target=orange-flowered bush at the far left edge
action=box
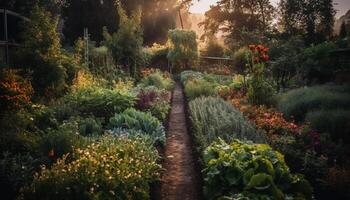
[0,68,33,111]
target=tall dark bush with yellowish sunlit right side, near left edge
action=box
[20,6,67,97]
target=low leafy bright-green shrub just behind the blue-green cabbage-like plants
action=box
[65,88,136,119]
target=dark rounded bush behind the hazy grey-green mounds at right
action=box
[300,42,336,83]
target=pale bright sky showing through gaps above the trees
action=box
[190,0,350,18]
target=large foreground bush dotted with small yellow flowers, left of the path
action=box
[22,136,161,200]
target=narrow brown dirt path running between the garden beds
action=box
[161,83,200,200]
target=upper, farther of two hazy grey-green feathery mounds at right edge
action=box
[278,86,350,122]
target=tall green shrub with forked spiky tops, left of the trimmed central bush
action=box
[103,4,144,76]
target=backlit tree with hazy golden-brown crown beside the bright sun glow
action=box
[202,0,274,44]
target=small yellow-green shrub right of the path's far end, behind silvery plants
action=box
[185,79,216,100]
